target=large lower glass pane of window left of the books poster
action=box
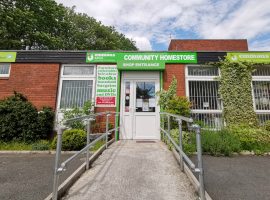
[60,80,93,108]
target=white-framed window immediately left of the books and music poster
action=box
[58,65,95,109]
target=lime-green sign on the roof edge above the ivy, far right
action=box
[227,52,270,63]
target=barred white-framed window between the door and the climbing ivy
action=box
[186,65,223,129]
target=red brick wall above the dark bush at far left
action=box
[0,63,60,109]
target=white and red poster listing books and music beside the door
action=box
[95,65,118,107]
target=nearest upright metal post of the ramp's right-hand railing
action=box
[193,125,205,200]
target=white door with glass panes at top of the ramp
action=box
[120,72,160,140]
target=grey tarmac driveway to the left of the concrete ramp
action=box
[0,154,85,200]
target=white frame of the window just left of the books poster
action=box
[57,64,97,112]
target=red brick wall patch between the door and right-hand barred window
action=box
[163,64,186,96]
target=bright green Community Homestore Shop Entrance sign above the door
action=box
[86,52,197,70]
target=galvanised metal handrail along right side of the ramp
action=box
[160,112,205,200]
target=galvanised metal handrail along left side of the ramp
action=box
[52,112,120,200]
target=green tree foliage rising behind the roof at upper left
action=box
[0,0,137,50]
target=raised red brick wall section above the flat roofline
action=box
[169,39,248,51]
